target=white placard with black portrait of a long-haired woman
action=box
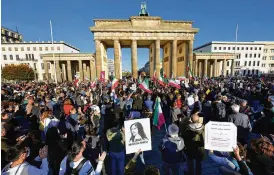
[125,118,151,154]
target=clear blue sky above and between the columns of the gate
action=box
[1,0,274,70]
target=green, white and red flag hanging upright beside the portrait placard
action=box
[153,97,165,130]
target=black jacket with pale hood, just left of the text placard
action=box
[183,123,206,160]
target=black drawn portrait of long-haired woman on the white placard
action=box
[129,122,148,143]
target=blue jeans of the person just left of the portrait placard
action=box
[109,151,125,175]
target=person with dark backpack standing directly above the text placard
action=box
[210,95,227,122]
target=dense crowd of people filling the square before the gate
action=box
[1,77,274,175]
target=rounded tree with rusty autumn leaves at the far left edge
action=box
[2,64,34,81]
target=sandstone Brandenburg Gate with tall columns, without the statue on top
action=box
[90,16,198,78]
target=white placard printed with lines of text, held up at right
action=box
[205,121,237,152]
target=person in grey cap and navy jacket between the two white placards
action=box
[159,124,185,175]
